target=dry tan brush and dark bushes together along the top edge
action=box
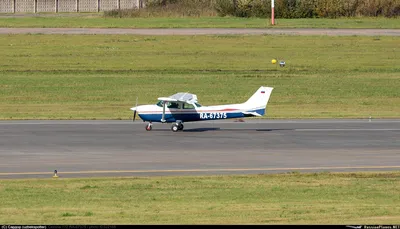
[105,0,400,18]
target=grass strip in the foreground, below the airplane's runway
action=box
[0,172,400,225]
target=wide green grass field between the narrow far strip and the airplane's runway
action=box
[0,35,400,119]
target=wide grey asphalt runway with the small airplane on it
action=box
[0,119,400,179]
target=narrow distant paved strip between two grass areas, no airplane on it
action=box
[0,28,400,36]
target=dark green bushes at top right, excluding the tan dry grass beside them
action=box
[147,0,400,18]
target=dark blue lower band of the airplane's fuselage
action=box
[138,108,265,122]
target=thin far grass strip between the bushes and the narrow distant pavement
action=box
[0,13,400,29]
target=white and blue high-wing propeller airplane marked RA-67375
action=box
[131,86,273,132]
